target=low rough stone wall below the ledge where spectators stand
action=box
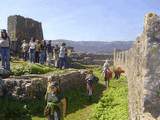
[0,71,85,99]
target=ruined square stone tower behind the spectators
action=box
[8,15,43,55]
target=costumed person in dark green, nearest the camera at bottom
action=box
[44,81,67,120]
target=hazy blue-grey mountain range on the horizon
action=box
[52,39,133,54]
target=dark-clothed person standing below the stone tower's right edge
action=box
[39,40,46,64]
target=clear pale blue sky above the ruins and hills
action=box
[0,0,160,41]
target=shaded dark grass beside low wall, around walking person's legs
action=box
[64,84,105,114]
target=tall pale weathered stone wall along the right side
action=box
[114,13,160,120]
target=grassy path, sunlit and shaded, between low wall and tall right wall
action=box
[33,69,128,120]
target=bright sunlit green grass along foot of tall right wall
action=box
[88,70,128,120]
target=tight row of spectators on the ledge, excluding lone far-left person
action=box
[21,38,67,68]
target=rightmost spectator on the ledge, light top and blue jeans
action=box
[59,43,66,69]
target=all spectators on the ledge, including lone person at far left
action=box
[0,29,68,71]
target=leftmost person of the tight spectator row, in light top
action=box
[21,40,29,61]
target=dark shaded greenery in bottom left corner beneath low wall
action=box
[0,98,45,120]
